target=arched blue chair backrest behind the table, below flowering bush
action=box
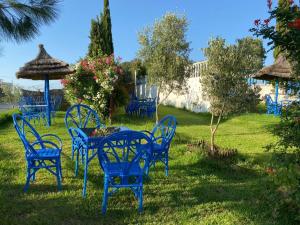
[65,104,104,136]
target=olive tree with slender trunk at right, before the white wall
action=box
[200,38,265,154]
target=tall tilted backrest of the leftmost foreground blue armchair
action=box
[12,114,45,157]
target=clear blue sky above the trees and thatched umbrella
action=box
[0,0,273,89]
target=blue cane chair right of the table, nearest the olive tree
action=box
[144,115,177,176]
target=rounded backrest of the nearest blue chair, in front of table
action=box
[98,131,152,175]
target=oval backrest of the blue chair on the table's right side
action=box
[151,115,177,146]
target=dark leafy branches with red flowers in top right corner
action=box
[250,0,300,77]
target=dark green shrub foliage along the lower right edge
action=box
[267,102,300,222]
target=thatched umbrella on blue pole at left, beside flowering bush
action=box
[16,45,75,126]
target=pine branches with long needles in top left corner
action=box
[0,0,59,41]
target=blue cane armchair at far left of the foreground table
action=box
[13,114,62,192]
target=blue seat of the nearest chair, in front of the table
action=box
[105,162,143,176]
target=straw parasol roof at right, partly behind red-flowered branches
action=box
[252,55,293,80]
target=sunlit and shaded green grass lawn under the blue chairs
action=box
[0,107,288,225]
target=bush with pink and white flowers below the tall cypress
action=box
[61,55,123,117]
